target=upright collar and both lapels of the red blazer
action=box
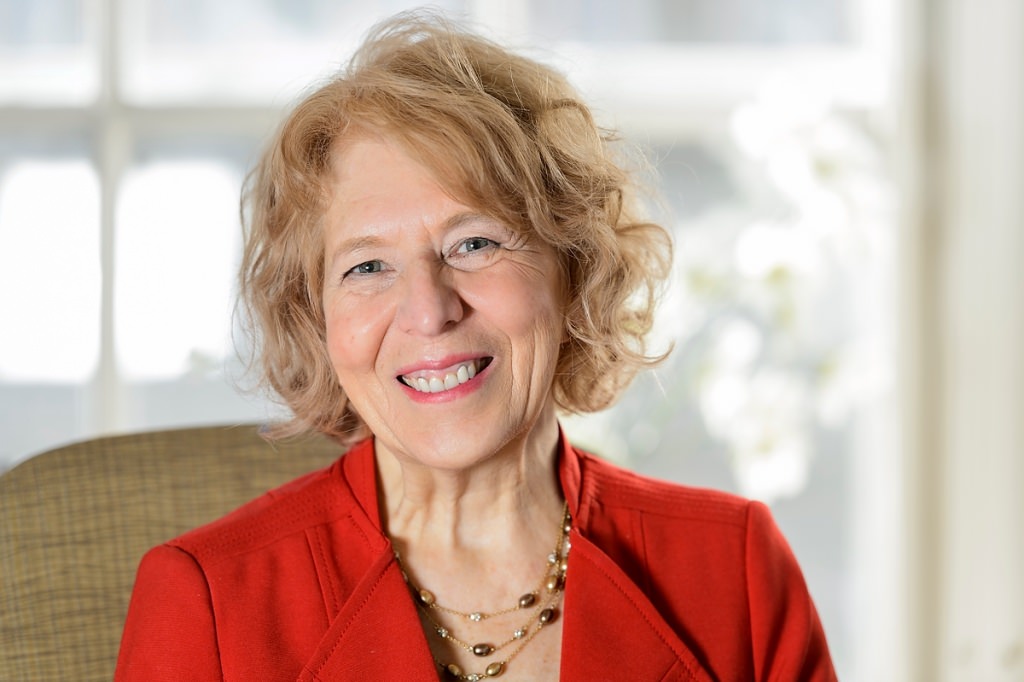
[299,433,713,682]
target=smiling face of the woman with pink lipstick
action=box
[324,136,564,469]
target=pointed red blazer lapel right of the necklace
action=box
[560,530,713,682]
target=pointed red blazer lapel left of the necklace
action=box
[299,550,437,682]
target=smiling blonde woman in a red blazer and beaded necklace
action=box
[118,11,835,680]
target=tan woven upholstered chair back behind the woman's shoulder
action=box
[0,425,340,682]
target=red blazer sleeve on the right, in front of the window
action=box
[745,502,837,682]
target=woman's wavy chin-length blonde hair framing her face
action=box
[240,13,672,444]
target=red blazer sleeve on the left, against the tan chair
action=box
[114,545,223,682]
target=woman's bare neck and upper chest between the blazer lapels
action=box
[375,406,565,679]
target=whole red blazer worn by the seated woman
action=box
[116,430,836,682]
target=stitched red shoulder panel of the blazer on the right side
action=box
[577,449,755,527]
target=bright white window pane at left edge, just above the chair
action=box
[0,152,100,382]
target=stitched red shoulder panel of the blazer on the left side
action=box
[168,458,355,563]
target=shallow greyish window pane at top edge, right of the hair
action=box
[529,0,852,44]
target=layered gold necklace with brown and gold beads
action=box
[395,505,572,682]
